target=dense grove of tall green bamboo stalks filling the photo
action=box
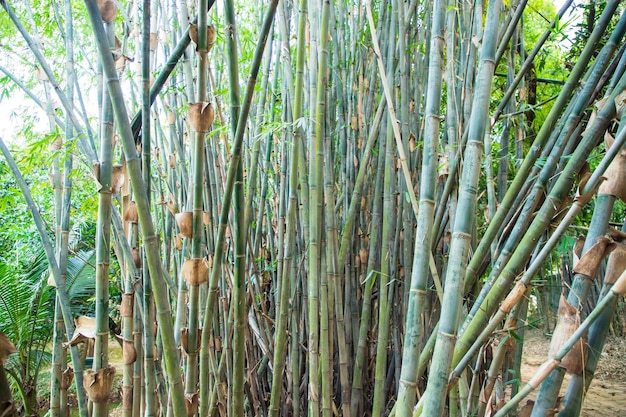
[0,0,626,417]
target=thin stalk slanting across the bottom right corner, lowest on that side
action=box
[494,271,626,417]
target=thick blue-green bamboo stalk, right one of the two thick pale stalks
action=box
[416,1,502,416]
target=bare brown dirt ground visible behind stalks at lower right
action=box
[522,330,626,417]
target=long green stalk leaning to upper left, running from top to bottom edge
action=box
[80,0,186,417]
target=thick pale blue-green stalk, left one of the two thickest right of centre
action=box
[396,0,444,417]
